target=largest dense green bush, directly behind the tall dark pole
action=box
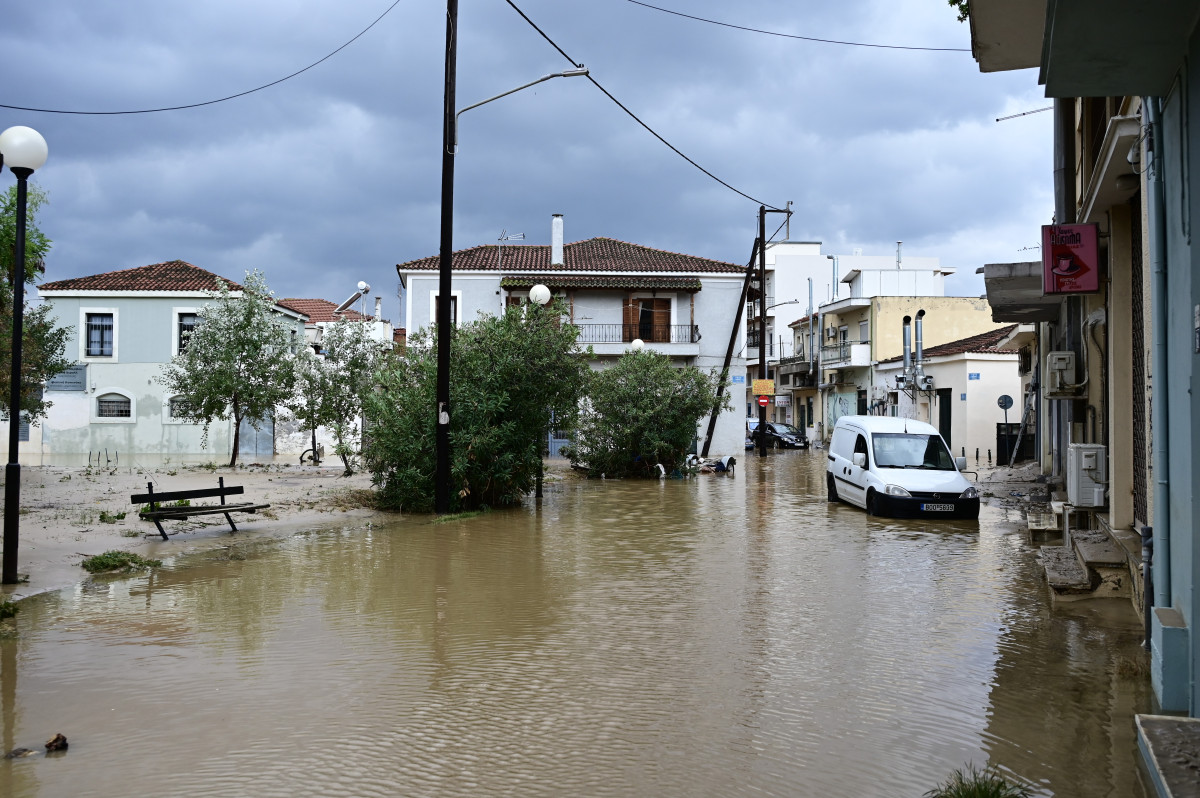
[365,302,590,512]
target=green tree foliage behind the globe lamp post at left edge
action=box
[0,184,73,421]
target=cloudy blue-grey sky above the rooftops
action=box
[0,0,1052,320]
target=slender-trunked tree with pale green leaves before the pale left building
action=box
[158,271,295,467]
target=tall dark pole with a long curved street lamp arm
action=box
[433,0,588,515]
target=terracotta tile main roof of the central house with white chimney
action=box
[396,236,745,275]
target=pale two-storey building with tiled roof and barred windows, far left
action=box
[26,260,306,462]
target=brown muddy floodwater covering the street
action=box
[0,451,1150,798]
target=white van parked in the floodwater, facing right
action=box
[826,415,979,518]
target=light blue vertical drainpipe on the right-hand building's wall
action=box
[1141,97,1174,607]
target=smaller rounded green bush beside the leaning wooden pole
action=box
[563,349,730,478]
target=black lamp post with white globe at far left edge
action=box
[0,125,49,584]
